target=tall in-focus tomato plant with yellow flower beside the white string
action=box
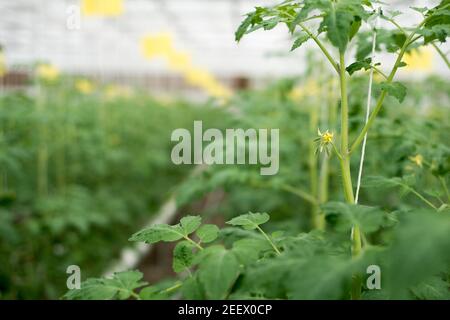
[232,0,450,299]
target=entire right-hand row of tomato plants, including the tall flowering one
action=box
[64,0,450,299]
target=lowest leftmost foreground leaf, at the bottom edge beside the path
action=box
[64,271,147,300]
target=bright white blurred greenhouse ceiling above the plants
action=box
[0,0,448,77]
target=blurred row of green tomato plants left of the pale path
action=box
[0,72,224,299]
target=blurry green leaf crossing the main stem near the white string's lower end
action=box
[322,202,386,233]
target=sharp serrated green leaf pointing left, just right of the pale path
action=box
[129,224,184,243]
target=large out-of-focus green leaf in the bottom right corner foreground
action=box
[382,209,450,299]
